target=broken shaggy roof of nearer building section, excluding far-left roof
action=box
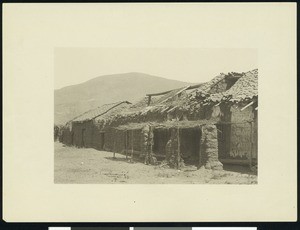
[97,70,257,126]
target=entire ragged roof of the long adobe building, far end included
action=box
[65,69,258,127]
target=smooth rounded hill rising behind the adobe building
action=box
[54,72,190,124]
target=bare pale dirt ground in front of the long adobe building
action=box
[54,142,257,184]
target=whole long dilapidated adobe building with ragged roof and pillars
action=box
[59,69,258,169]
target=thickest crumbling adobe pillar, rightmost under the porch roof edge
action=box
[199,125,223,170]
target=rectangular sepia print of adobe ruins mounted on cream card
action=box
[54,48,259,184]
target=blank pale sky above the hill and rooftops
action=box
[54,48,258,89]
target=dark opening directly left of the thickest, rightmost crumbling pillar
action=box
[180,128,201,166]
